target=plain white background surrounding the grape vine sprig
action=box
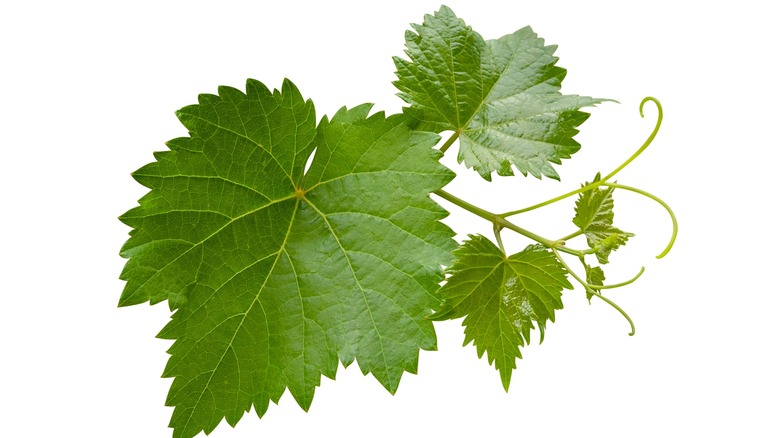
[0,0,780,438]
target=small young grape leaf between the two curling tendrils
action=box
[572,173,634,264]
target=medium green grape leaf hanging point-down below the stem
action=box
[431,235,572,391]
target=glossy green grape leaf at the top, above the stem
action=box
[394,6,605,181]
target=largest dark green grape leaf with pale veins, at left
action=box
[120,80,456,437]
